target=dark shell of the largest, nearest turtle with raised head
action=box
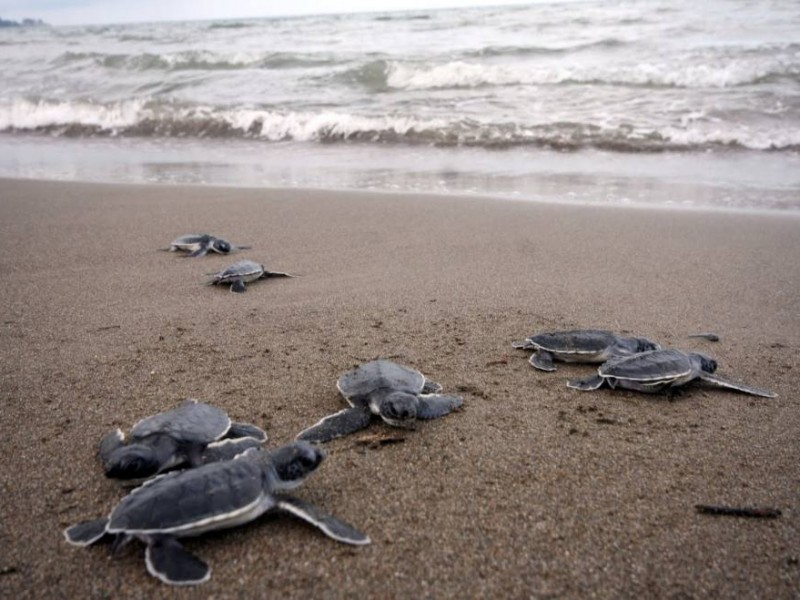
[108,459,268,536]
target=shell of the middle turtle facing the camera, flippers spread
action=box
[336,360,425,404]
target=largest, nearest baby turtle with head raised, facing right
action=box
[64,442,370,585]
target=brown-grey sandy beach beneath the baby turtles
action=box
[0,180,800,598]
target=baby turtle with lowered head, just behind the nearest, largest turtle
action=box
[100,399,267,481]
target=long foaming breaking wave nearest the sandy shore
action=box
[0,100,800,152]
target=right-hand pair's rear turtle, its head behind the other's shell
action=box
[512,329,661,371]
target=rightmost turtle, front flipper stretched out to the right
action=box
[567,350,775,398]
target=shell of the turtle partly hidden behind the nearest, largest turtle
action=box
[131,400,231,444]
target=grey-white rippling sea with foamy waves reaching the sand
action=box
[0,0,800,211]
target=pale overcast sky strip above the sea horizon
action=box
[0,0,558,25]
